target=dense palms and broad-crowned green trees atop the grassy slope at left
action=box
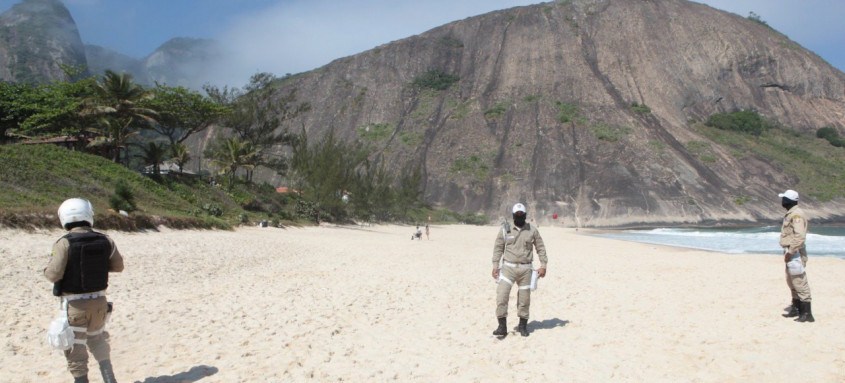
[0,69,229,166]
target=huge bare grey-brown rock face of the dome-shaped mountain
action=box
[247,0,845,226]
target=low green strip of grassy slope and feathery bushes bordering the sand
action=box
[0,142,442,230]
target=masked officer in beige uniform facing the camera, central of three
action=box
[493,203,548,336]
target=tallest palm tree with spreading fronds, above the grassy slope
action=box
[82,70,157,162]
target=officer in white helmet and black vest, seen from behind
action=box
[44,198,123,383]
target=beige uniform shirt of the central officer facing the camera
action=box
[493,222,548,269]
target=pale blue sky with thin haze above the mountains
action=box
[0,0,845,86]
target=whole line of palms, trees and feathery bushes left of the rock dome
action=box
[0,69,424,222]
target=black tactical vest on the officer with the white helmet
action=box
[60,232,112,294]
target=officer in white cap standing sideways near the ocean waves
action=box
[778,190,816,322]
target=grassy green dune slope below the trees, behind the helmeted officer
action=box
[0,145,285,229]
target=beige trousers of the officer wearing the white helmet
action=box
[65,297,111,377]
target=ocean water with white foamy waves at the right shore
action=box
[596,226,845,259]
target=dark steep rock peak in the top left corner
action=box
[0,0,86,83]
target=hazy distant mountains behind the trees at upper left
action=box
[0,0,222,89]
